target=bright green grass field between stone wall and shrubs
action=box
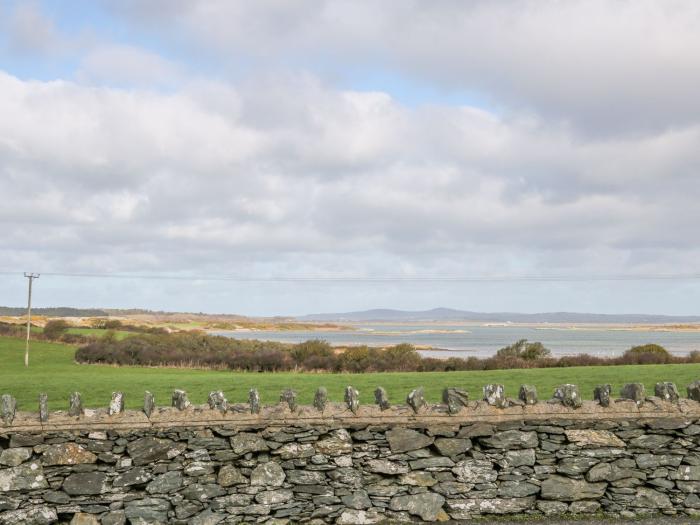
[0,337,700,410]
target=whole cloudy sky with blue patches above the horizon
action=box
[0,0,700,315]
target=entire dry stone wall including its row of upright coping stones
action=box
[0,384,700,525]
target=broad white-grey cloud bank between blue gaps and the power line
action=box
[0,68,700,286]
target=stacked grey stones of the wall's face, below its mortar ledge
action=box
[0,418,700,524]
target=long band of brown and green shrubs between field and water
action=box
[75,332,700,373]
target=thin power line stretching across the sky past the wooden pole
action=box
[0,271,700,283]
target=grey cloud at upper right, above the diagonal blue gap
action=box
[104,0,700,136]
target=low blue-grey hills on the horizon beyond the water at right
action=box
[296,308,700,324]
